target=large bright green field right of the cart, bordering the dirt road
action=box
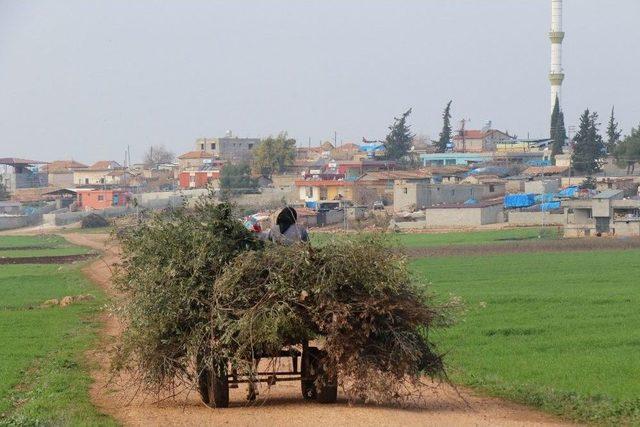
[412,250,640,424]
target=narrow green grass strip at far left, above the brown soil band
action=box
[0,236,90,258]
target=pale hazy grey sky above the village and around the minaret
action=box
[0,0,640,162]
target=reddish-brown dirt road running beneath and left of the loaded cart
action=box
[65,234,567,426]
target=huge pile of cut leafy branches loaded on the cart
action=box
[113,197,456,401]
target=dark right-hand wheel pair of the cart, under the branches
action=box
[302,347,338,403]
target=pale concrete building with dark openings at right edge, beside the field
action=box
[561,190,640,237]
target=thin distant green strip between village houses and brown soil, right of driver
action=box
[311,227,561,248]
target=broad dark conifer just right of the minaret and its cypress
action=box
[571,109,605,175]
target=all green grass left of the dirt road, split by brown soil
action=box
[0,236,111,425]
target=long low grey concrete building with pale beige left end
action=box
[393,180,506,212]
